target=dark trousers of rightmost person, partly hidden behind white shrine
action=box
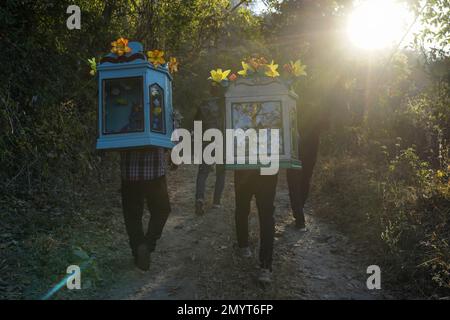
[286,129,319,223]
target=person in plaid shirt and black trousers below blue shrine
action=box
[120,147,170,271]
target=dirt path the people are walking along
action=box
[99,166,386,299]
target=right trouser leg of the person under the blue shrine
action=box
[145,176,170,252]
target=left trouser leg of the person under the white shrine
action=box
[234,170,253,248]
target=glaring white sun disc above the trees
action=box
[347,0,413,49]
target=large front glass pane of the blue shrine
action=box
[103,77,144,134]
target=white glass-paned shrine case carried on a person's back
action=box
[225,77,302,170]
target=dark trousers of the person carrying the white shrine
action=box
[234,170,278,269]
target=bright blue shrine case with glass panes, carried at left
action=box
[97,42,174,149]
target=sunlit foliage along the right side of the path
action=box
[267,1,450,296]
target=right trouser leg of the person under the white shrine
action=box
[256,175,278,271]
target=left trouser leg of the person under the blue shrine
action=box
[121,181,144,257]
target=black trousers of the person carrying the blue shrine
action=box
[122,176,170,256]
